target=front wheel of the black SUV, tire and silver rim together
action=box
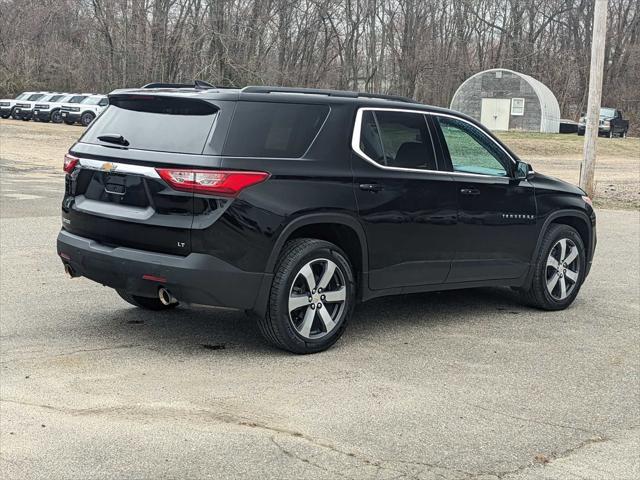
[523,224,587,310]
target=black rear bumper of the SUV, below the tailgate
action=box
[57,230,271,310]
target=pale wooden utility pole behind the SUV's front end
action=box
[580,0,609,198]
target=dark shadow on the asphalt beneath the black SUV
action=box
[100,288,528,356]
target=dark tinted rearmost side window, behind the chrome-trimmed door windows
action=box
[223,102,329,158]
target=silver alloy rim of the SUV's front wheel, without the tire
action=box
[546,238,580,301]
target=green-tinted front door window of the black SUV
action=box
[437,117,507,177]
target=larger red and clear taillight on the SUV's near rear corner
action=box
[156,168,269,197]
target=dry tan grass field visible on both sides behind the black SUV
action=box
[0,120,640,209]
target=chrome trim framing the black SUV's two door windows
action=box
[351,107,517,179]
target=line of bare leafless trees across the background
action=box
[0,0,640,125]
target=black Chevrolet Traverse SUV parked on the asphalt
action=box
[57,85,596,353]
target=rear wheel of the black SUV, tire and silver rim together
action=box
[258,238,355,353]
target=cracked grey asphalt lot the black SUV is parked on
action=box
[0,138,640,480]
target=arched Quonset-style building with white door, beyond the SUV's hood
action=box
[451,68,560,133]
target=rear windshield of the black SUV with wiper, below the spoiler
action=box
[82,96,217,154]
